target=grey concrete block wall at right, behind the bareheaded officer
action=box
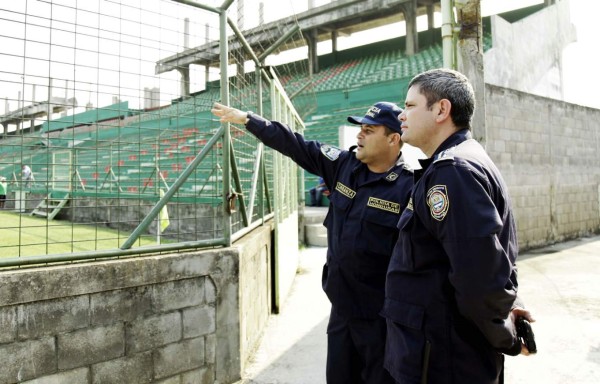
[486,84,600,250]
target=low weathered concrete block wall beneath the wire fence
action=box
[0,226,272,384]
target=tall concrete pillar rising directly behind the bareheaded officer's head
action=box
[457,0,487,147]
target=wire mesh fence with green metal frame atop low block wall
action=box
[0,0,315,266]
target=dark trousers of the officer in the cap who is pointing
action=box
[326,309,395,384]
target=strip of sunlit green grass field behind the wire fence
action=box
[0,211,156,258]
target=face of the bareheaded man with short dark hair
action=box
[398,86,439,153]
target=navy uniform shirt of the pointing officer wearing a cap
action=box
[246,114,413,318]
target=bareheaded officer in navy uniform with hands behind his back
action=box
[382,69,533,384]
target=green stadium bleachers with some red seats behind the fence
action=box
[0,31,491,206]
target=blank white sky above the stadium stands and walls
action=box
[0,0,600,121]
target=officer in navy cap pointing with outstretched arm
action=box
[212,102,412,384]
